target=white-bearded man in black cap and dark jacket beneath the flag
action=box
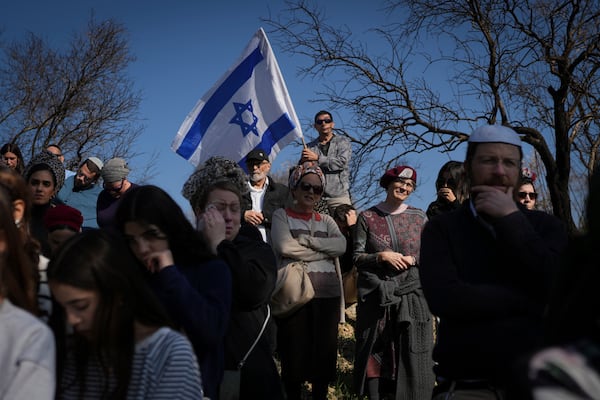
[242,149,289,243]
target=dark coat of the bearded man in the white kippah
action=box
[420,201,567,386]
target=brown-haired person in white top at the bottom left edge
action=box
[0,187,55,400]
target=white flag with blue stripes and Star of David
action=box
[171,28,302,169]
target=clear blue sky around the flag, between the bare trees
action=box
[0,0,464,213]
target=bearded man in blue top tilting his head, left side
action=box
[58,157,104,228]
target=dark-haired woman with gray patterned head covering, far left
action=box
[23,150,65,257]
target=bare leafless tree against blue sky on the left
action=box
[0,17,142,169]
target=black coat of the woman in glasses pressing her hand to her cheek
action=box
[217,224,283,400]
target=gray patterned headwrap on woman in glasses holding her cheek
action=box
[183,156,249,207]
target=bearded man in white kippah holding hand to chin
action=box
[420,125,567,400]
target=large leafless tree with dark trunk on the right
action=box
[265,0,600,234]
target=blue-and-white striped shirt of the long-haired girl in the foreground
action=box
[57,327,203,400]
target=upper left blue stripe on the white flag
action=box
[176,47,264,160]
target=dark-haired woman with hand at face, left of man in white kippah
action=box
[427,161,466,219]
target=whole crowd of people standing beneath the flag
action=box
[0,111,600,400]
